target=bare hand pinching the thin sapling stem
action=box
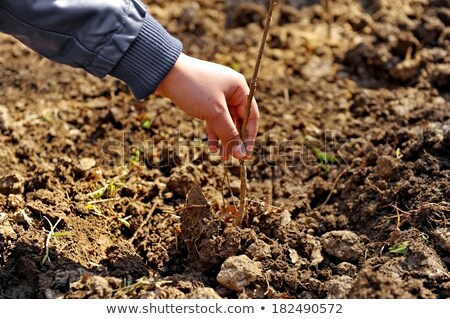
[156,54,259,160]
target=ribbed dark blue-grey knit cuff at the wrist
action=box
[109,15,183,99]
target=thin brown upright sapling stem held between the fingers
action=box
[234,0,276,226]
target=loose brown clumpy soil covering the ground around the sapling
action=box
[0,0,450,298]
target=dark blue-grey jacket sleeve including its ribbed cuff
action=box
[0,0,182,99]
